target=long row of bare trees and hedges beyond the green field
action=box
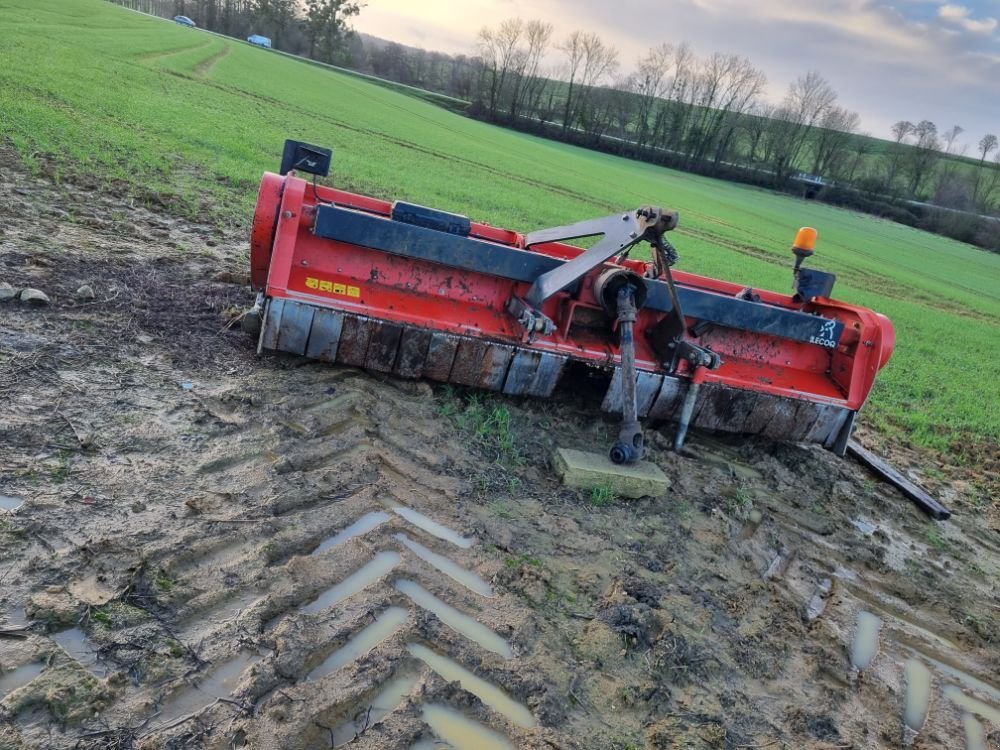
[105,0,1000,249]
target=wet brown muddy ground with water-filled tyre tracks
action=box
[0,156,1000,750]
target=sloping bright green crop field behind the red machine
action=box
[0,0,1000,457]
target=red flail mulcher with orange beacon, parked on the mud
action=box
[250,141,894,463]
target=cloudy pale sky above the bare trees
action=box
[354,0,1000,155]
